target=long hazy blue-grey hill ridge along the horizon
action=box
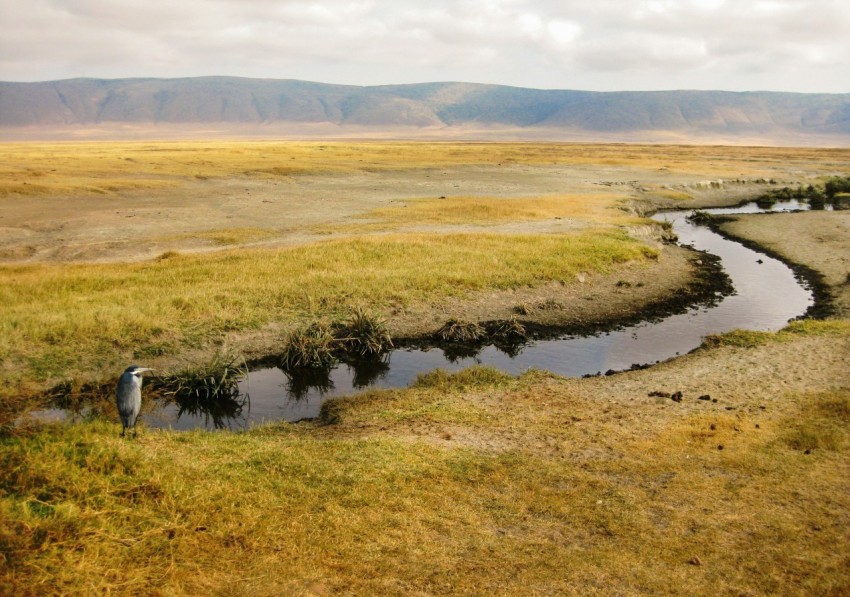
[0,77,850,145]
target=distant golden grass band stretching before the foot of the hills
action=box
[6,141,850,197]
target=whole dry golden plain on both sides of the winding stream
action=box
[0,142,850,595]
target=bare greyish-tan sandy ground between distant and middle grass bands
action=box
[0,165,780,263]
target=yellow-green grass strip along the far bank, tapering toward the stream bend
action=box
[0,229,657,380]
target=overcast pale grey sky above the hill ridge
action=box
[0,0,850,93]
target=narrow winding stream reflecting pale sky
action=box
[137,202,814,430]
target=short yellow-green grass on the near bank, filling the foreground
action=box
[0,369,850,595]
